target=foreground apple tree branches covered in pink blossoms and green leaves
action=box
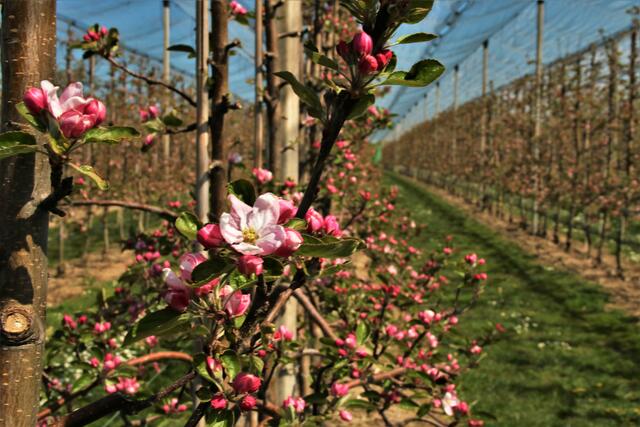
[0,0,497,426]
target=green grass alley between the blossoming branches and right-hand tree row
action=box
[386,175,640,427]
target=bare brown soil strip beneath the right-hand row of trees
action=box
[423,184,640,317]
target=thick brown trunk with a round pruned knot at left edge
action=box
[0,0,56,427]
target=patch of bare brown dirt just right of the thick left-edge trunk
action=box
[47,248,133,306]
